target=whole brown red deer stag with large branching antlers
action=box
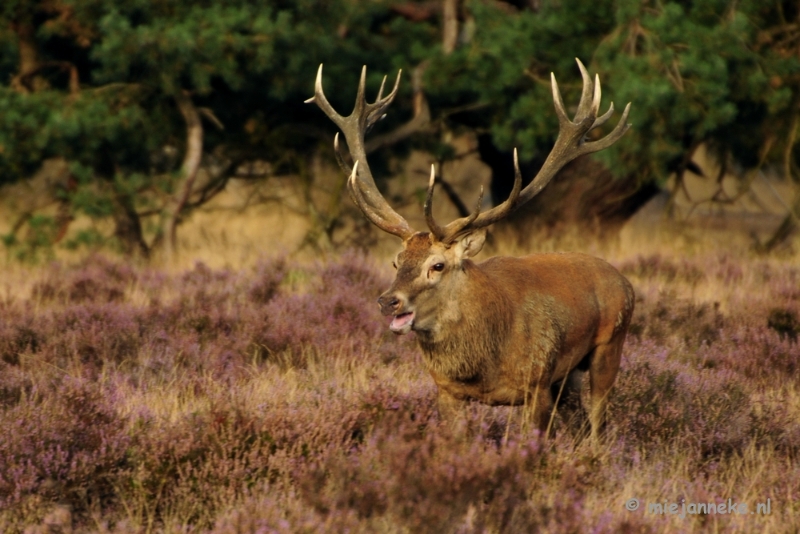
[306,59,635,441]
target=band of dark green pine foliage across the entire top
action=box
[0,0,800,255]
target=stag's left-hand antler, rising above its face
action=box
[306,65,414,239]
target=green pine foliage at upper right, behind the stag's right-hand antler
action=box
[428,0,800,182]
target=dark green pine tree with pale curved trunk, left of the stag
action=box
[0,0,434,255]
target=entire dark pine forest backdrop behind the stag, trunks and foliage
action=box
[0,0,800,259]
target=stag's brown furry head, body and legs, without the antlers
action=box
[379,232,634,437]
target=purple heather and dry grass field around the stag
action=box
[0,239,800,533]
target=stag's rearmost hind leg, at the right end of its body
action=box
[589,336,625,442]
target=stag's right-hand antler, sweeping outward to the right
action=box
[425,58,631,244]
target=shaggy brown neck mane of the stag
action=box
[417,260,513,380]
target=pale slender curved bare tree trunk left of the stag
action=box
[163,91,203,262]
